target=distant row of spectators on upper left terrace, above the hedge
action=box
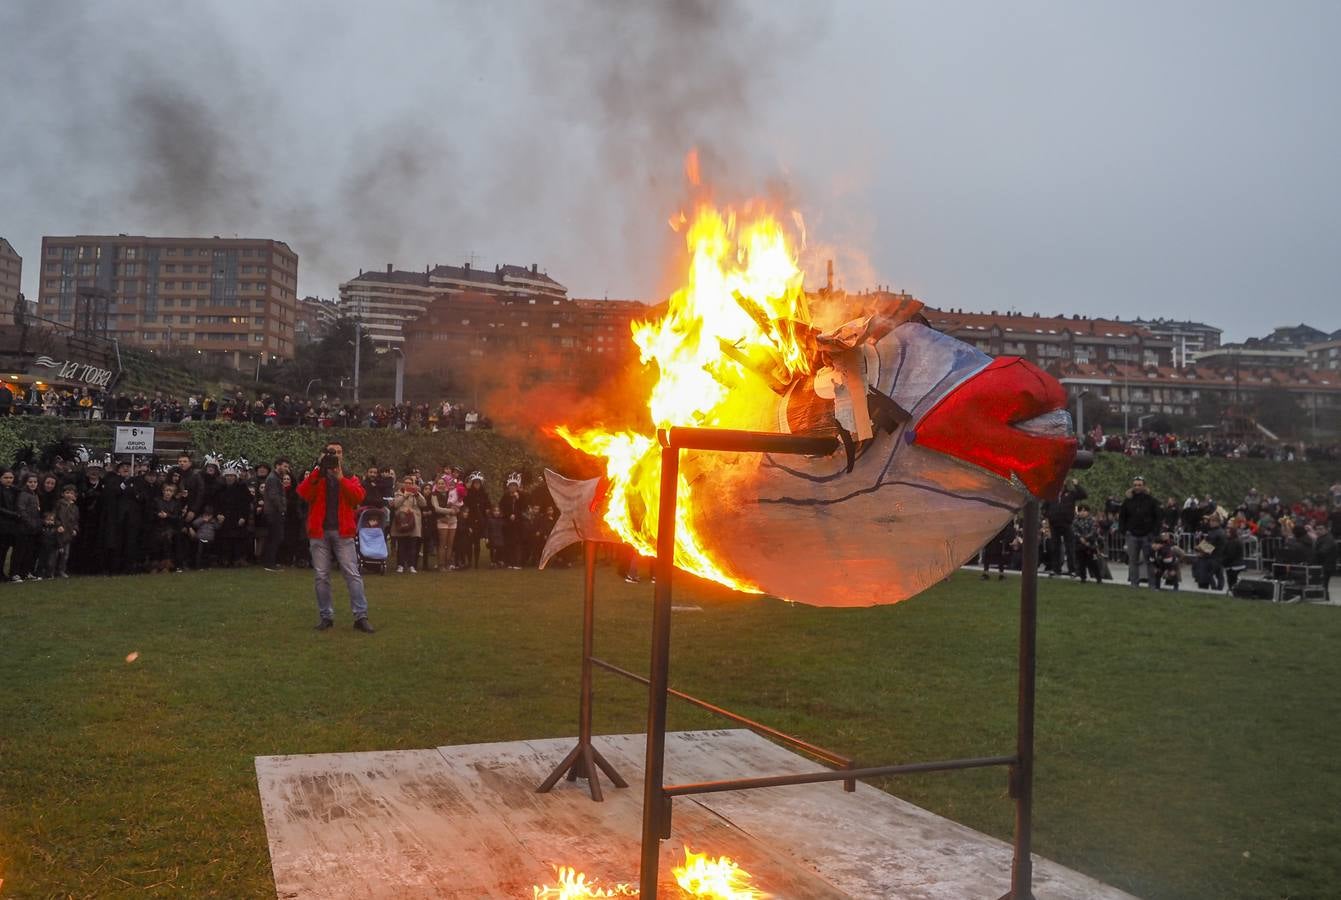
[0,382,493,431]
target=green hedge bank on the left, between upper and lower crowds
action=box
[0,416,546,487]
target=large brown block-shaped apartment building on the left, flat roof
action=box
[36,235,298,369]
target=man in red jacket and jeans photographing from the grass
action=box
[298,441,373,634]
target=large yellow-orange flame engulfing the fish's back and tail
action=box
[557,205,814,592]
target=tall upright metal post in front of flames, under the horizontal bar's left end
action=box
[638,432,680,900]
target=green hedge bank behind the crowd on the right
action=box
[1077,453,1341,506]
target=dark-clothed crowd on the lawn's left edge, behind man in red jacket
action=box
[0,445,566,582]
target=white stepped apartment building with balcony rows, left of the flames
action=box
[339,263,569,347]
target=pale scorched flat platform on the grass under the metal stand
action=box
[256,730,1129,900]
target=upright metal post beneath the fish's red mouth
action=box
[1006,498,1039,900]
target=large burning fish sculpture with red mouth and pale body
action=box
[542,207,1077,606]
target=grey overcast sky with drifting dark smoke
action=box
[0,0,1341,338]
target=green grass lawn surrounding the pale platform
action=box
[0,569,1341,899]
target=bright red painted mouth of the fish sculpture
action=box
[913,357,1077,499]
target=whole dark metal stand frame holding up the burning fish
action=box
[538,428,1039,900]
